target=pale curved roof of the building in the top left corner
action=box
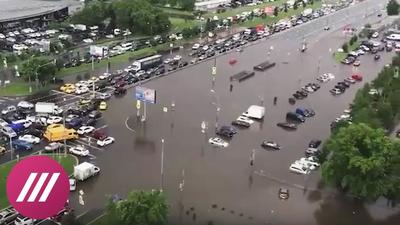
[0,0,77,22]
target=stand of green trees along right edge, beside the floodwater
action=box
[322,55,400,203]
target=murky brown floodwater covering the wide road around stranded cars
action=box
[67,0,400,225]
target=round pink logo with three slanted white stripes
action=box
[7,156,69,219]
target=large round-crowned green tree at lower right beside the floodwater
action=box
[322,124,400,200]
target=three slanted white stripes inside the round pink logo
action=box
[16,173,60,202]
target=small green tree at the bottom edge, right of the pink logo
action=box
[116,190,168,225]
